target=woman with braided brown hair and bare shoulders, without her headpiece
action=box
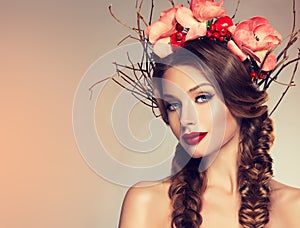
[115,1,300,228]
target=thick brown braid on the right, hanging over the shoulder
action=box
[239,113,274,228]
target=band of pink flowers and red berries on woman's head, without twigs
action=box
[146,0,282,78]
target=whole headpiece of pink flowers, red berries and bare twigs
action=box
[95,0,300,115]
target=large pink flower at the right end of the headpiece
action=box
[228,17,282,71]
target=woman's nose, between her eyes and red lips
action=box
[180,100,198,127]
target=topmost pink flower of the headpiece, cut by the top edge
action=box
[190,0,226,21]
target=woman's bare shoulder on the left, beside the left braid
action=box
[119,182,170,228]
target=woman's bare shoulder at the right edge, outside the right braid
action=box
[271,180,300,228]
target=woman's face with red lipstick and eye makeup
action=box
[162,66,239,158]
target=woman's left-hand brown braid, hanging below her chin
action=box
[169,144,206,228]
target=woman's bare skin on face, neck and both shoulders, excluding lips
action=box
[119,68,300,228]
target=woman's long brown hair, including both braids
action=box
[153,39,274,228]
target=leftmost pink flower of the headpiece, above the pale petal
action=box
[146,4,182,44]
